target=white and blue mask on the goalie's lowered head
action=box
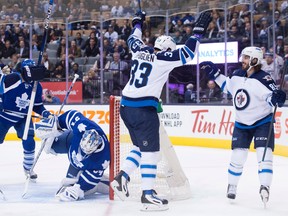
[80,129,104,154]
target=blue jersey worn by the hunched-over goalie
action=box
[58,110,110,170]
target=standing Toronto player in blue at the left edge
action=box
[0,59,51,179]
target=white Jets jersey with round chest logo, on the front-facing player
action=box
[215,70,276,126]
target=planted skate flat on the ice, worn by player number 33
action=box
[141,190,169,211]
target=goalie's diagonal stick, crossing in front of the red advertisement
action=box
[22,74,79,198]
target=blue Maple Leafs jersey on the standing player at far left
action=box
[0,72,45,123]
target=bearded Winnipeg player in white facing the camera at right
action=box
[200,47,286,204]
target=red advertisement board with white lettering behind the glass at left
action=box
[41,82,83,103]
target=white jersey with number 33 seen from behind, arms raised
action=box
[121,28,199,107]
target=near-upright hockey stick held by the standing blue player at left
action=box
[22,0,53,140]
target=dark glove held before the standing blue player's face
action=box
[21,65,47,82]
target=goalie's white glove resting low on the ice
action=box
[59,184,84,202]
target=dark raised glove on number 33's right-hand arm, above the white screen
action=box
[193,11,212,38]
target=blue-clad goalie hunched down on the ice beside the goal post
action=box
[35,110,110,201]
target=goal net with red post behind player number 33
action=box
[109,96,191,200]
